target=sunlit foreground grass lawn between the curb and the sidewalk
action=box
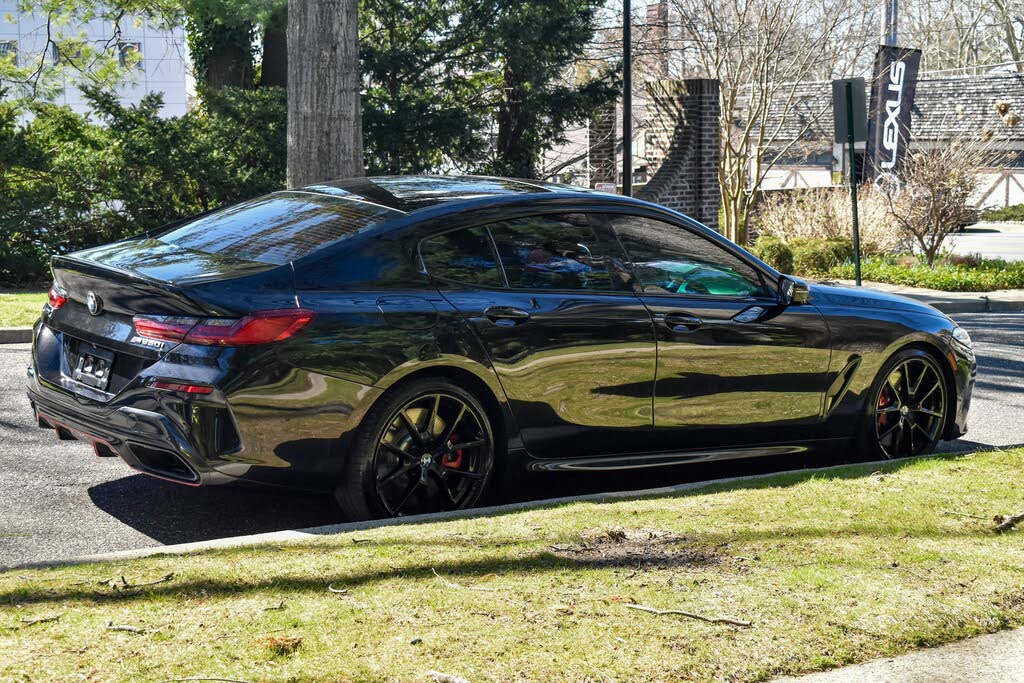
[0,450,1024,683]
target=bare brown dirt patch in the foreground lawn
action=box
[551,528,727,569]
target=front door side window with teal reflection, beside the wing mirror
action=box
[610,216,768,297]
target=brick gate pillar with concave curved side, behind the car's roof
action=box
[637,78,722,229]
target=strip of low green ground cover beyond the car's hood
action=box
[827,256,1024,292]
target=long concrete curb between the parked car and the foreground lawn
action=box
[0,452,929,571]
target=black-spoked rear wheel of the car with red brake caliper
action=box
[336,378,495,519]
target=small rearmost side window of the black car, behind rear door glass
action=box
[420,227,505,287]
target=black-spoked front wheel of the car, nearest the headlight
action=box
[863,349,949,458]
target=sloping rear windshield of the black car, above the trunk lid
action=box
[159,191,402,265]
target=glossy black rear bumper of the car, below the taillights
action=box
[27,324,382,490]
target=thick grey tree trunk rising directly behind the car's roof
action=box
[288,0,364,187]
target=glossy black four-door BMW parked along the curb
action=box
[29,176,975,518]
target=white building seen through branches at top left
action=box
[0,0,188,117]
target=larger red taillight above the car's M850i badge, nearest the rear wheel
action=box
[134,308,315,346]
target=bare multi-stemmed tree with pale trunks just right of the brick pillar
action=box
[673,0,878,244]
